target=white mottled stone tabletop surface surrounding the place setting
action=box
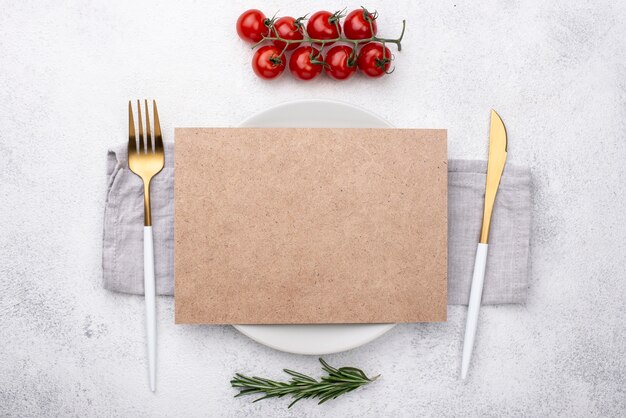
[0,0,626,417]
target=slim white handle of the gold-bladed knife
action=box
[461,244,489,379]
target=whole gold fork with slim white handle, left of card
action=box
[128,100,164,392]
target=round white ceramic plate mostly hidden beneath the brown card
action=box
[235,100,395,355]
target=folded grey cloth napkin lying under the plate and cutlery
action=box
[102,143,531,305]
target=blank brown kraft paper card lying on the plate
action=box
[174,128,448,324]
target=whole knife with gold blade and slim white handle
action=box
[461,109,507,379]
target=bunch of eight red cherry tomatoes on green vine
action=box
[237,7,406,80]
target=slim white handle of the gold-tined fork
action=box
[143,226,156,392]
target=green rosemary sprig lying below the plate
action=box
[230,358,378,408]
